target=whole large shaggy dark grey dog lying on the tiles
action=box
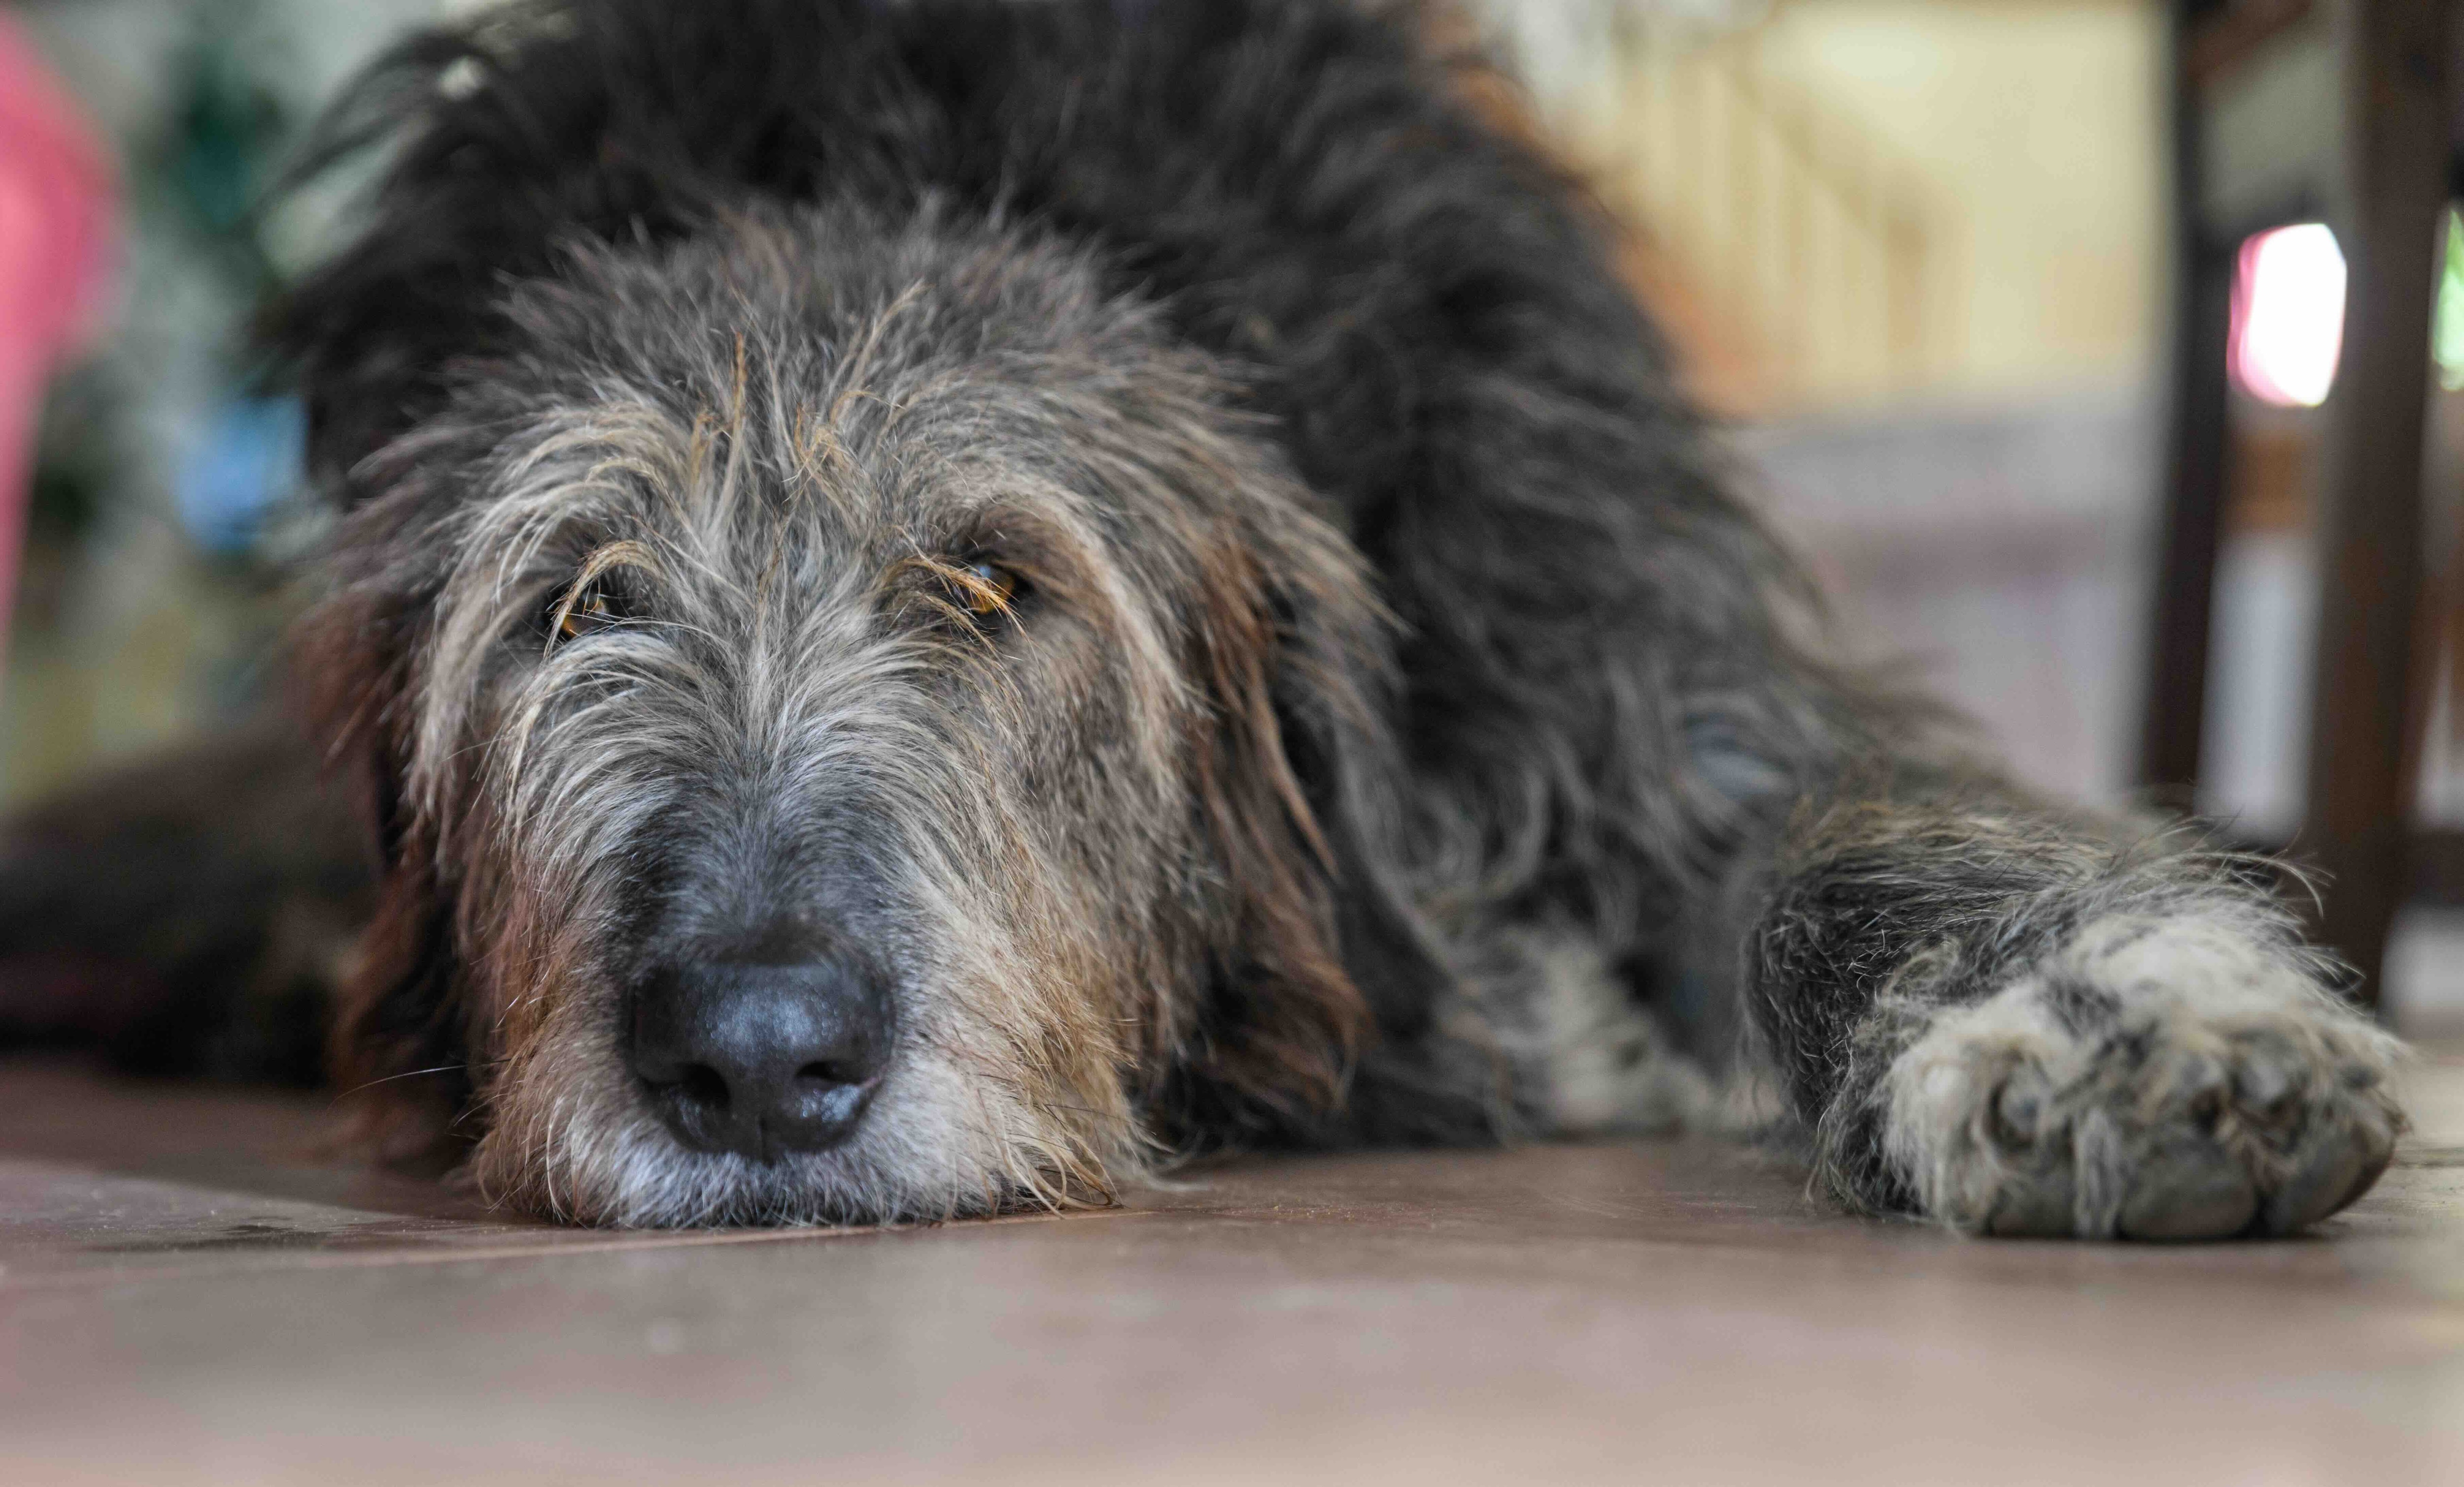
[0,0,2402,1238]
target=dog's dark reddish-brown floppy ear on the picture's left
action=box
[293,593,476,1162]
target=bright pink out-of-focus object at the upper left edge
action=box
[0,15,113,655]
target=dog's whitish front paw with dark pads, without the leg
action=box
[1882,916,2405,1238]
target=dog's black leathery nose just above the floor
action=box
[633,960,892,1162]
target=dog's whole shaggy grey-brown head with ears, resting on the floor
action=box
[306,209,1385,1223]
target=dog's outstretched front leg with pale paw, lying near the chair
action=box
[1745,795,2402,1238]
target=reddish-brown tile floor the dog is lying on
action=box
[0,1051,2464,1487]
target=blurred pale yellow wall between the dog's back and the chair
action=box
[1506,0,2166,413]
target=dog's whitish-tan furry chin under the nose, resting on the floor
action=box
[471,1039,1119,1228]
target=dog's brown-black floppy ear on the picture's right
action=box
[1163,534,1444,1140]
